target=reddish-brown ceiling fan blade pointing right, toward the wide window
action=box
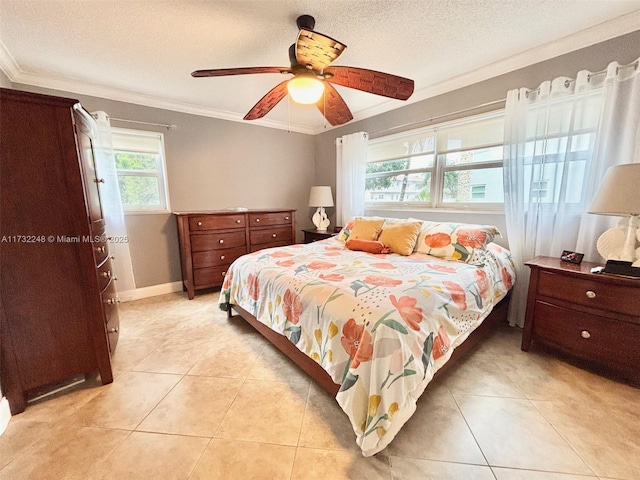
[324,67,414,100]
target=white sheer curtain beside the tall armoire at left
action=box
[92,112,136,300]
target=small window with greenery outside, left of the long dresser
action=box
[112,128,169,212]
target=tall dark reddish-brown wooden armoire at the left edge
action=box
[0,89,119,414]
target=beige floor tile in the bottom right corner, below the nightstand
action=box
[533,401,640,480]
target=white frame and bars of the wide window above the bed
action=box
[365,112,505,212]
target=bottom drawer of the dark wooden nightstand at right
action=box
[533,301,640,378]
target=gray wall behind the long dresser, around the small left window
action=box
[6,84,314,288]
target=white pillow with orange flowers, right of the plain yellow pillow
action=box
[416,223,500,263]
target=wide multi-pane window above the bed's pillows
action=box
[365,111,504,208]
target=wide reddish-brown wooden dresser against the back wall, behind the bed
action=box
[173,210,295,299]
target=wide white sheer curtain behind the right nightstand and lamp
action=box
[504,56,640,326]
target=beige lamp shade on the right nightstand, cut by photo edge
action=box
[589,163,640,217]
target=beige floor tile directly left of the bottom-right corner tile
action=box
[455,395,593,475]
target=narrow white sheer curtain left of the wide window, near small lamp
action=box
[336,132,369,225]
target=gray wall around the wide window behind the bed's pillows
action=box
[315,30,640,245]
